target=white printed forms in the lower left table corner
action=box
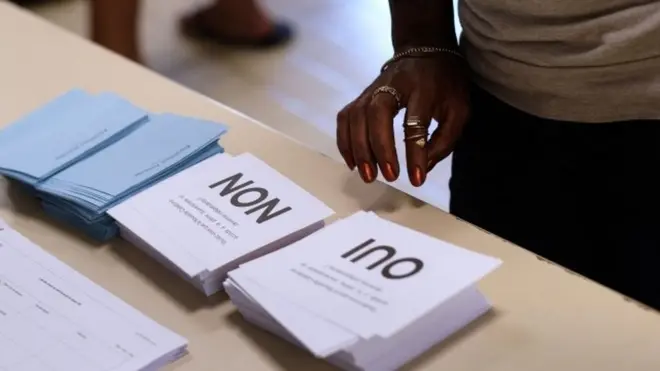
[0,221,187,371]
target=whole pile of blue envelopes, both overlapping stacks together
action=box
[0,90,226,241]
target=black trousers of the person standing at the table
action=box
[450,90,660,309]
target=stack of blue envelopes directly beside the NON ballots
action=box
[37,114,231,220]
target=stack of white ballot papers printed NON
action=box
[108,153,333,295]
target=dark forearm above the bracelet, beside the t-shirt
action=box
[389,0,457,52]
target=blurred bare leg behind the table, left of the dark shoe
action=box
[91,0,141,62]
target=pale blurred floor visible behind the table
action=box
[25,0,458,209]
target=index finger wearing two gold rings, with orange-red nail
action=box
[403,93,433,187]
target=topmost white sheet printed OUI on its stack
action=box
[239,213,501,339]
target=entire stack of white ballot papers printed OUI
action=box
[224,212,500,371]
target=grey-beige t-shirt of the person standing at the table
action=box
[459,0,660,122]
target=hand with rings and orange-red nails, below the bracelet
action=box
[337,53,470,187]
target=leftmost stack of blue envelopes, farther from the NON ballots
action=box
[0,90,148,185]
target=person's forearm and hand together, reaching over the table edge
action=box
[337,0,469,186]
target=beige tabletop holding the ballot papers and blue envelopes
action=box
[0,2,660,371]
